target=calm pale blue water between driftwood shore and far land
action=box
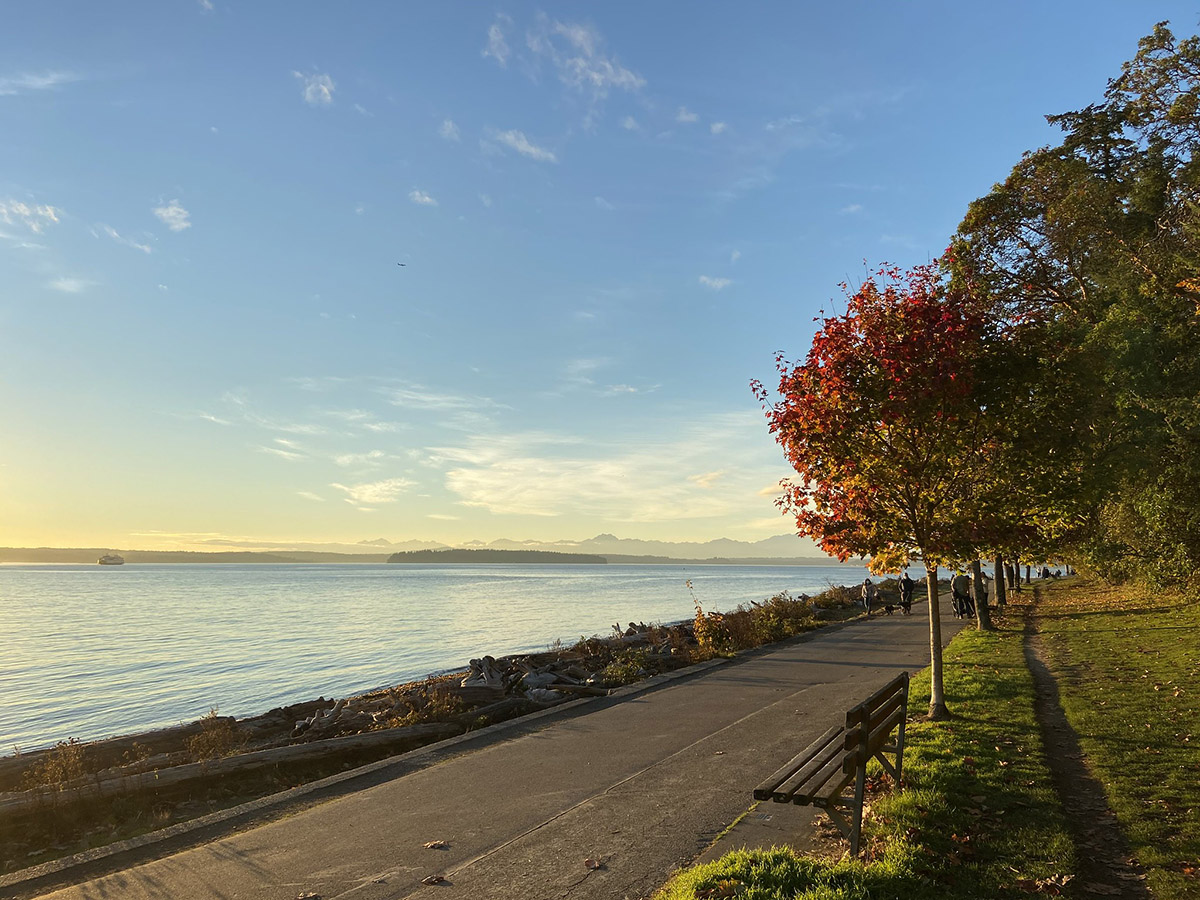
[0,564,863,754]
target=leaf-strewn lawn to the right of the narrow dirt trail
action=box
[1037,581,1200,900]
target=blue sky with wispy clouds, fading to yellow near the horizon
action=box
[0,0,1200,550]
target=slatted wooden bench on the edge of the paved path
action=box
[754,672,908,857]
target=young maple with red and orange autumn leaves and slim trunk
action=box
[752,263,1003,719]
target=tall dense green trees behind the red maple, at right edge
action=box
[955,23,1200,592]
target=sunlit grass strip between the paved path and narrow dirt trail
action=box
[656,617,1074,900]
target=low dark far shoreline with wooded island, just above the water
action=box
[0,547,863,568]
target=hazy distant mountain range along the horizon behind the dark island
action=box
[0,534,860,565]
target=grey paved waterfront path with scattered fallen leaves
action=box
[30,604,960,900]
